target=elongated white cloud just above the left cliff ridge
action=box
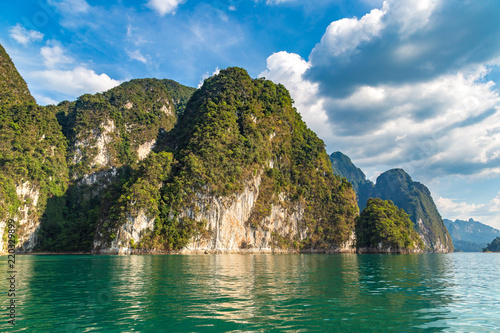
[30,67,120,98]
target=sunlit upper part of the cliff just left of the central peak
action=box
[57,79,194,177]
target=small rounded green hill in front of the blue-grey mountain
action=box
[356,198,423,252]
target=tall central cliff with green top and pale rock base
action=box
[94,68,358,253]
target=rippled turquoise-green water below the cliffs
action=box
[0,253,500,332]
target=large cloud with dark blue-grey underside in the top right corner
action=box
[306,0,500,97]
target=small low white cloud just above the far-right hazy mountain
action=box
[436,192,500,229]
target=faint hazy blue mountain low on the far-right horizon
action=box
[443,219,500,252]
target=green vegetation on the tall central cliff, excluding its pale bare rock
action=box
[97,68,357,250]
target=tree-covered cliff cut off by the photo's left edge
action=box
[0,45,68,253]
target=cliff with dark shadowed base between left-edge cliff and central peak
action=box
[36,79,195,251]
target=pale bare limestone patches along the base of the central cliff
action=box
[98,175,356,254]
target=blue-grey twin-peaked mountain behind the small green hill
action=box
[330,152,453,252]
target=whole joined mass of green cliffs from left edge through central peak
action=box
[0,44,358,253]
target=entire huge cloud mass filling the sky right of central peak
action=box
[261,0,500,184]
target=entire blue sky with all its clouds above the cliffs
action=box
[0,0,500,228]
